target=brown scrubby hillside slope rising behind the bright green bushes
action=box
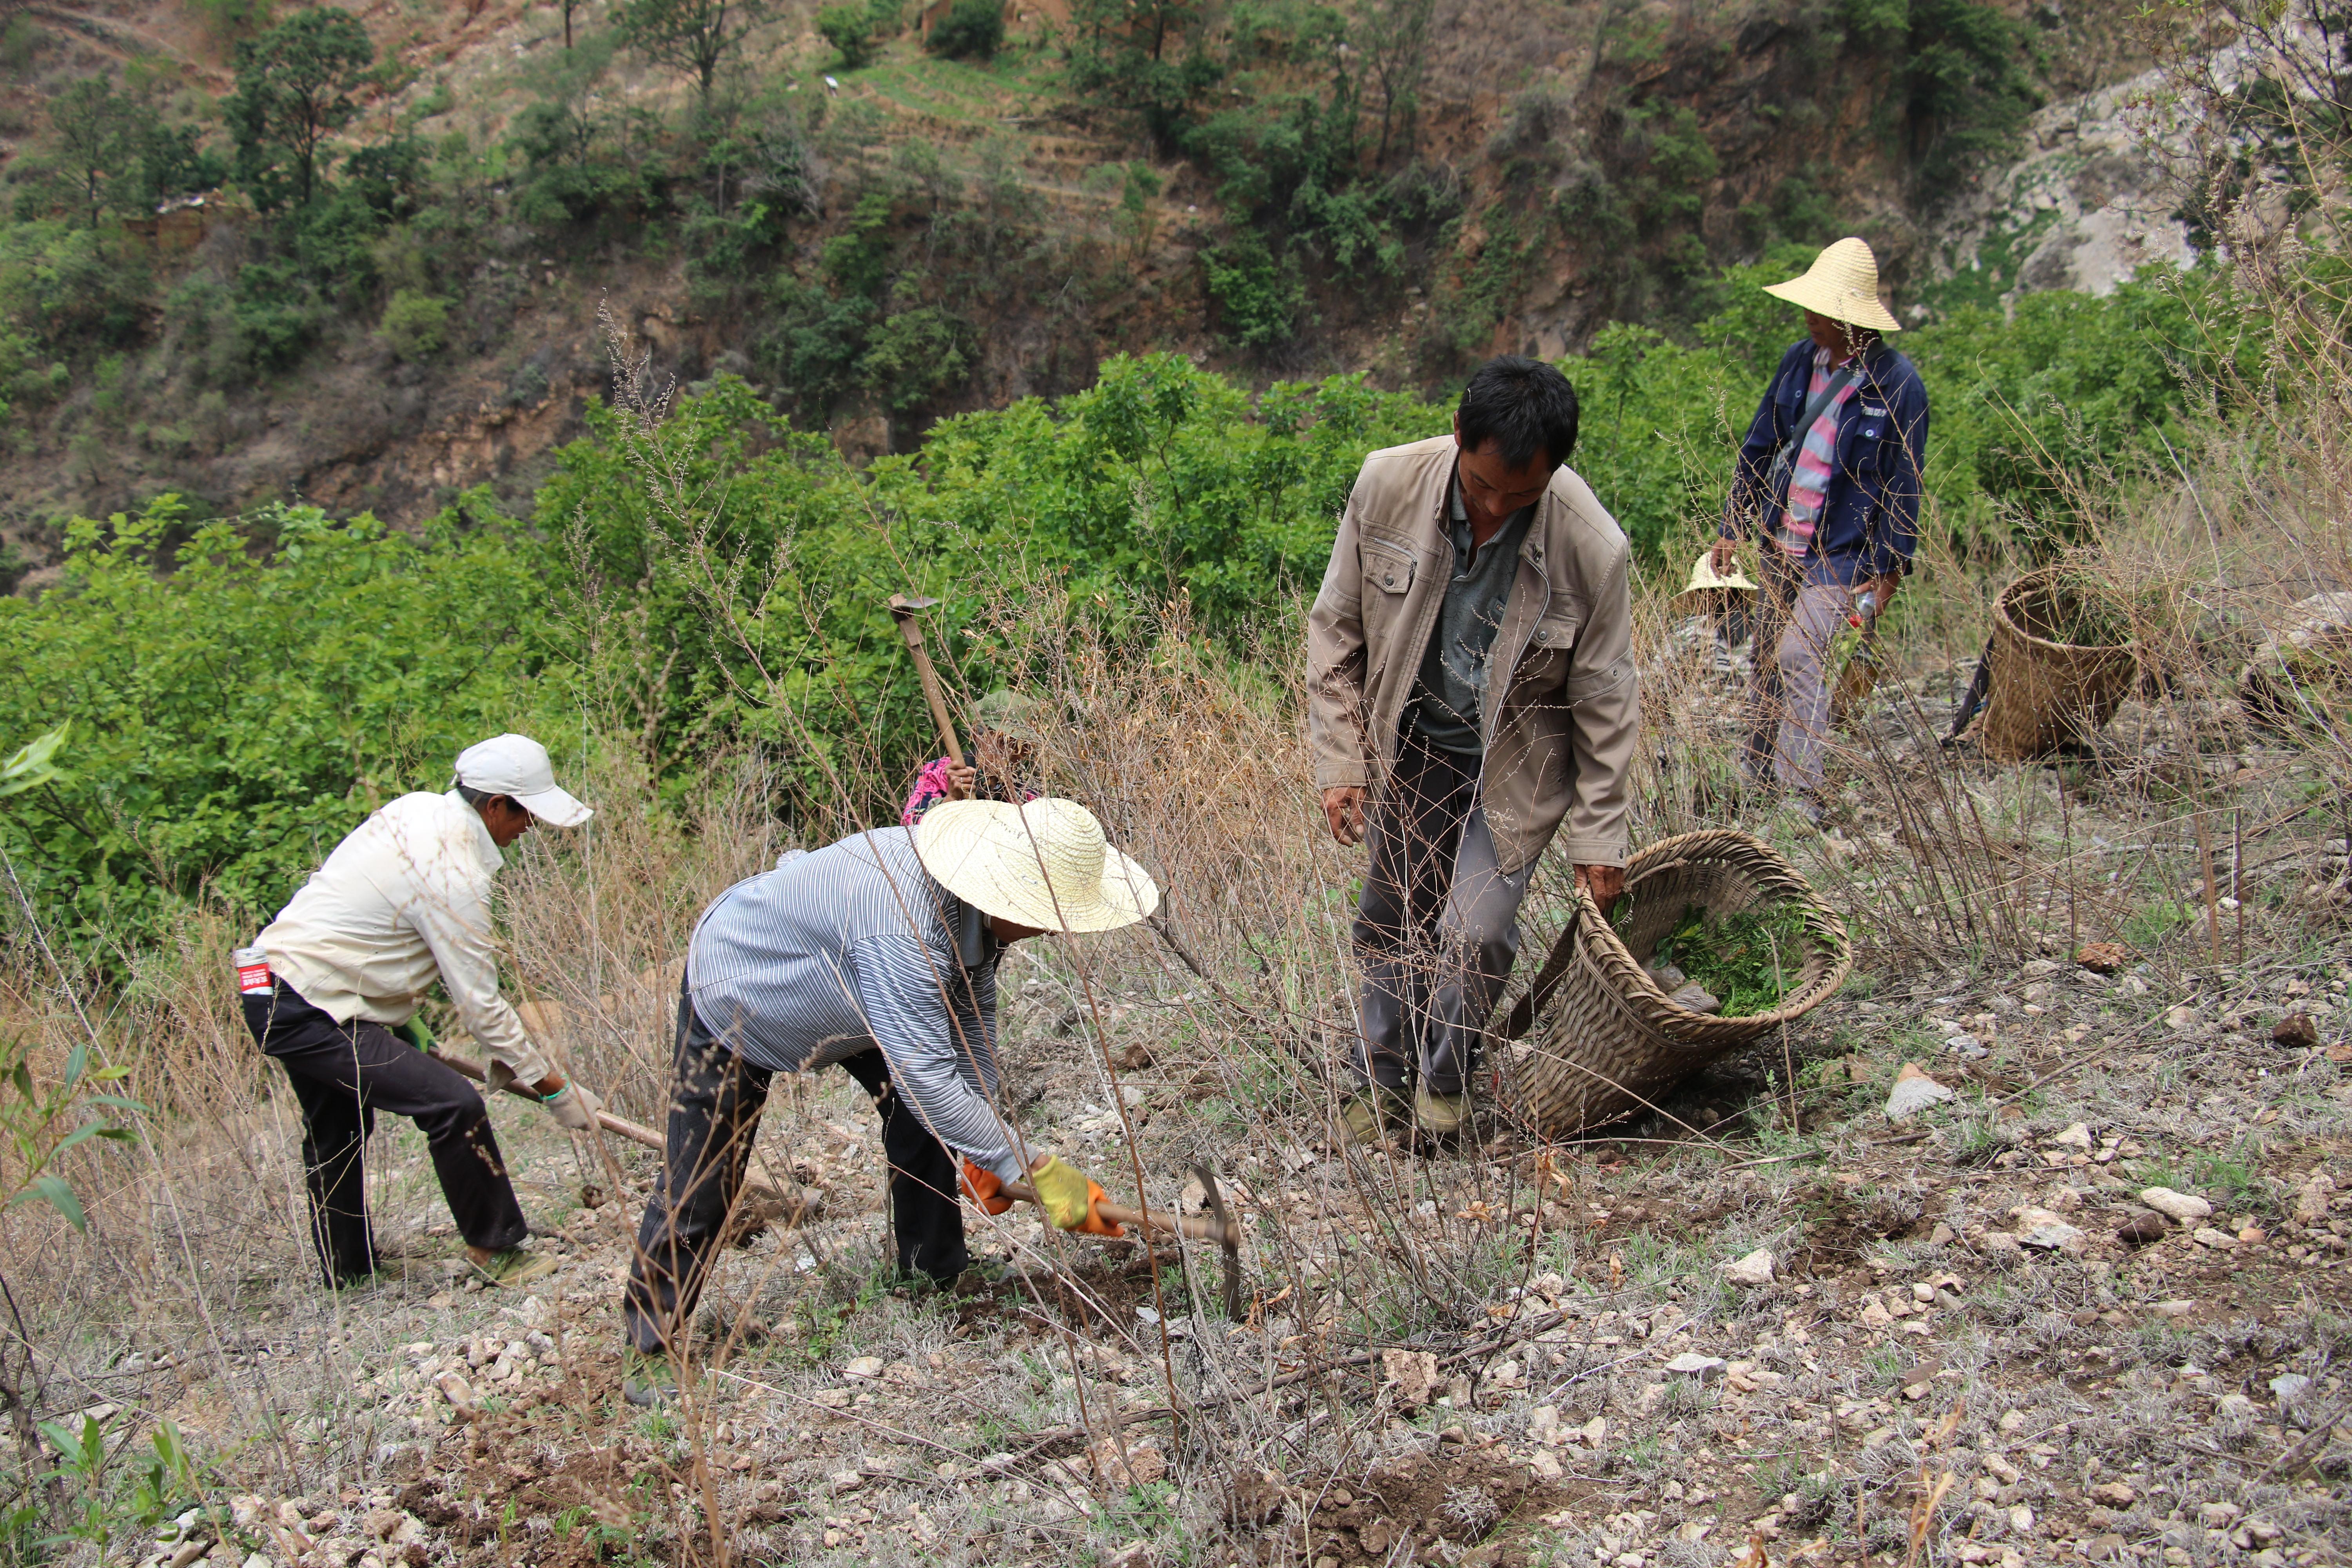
[0,0,2164,571]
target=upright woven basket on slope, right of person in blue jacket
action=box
[1983,566,2140,762]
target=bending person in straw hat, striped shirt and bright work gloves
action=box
[623,799,1160,1403]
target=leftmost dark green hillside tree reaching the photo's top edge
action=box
[221,5,376,207]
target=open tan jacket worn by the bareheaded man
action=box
[1308,435,1642,872]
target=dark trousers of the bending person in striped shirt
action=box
[621,995,971,1352]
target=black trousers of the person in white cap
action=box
[245,980,532,1286]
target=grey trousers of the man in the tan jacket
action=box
[1355,729,1534,1096]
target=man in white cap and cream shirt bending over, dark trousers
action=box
[238,736,597,1286]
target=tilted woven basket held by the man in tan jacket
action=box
[1508,828,1853,1138]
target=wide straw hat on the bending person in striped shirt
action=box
[915,799,1160,931]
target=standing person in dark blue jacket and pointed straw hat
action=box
[1715,240,1926,825]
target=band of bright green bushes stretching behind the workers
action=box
[0,261,2263,947]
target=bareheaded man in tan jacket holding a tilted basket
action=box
[1308,355,1642,1143]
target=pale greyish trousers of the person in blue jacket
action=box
[1743,541,1853,795]
